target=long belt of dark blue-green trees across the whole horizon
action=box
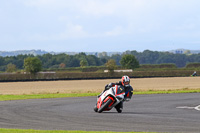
[0,50,200,71]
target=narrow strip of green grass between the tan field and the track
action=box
[0,88,200,101]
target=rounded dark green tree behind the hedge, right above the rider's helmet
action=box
[120,54,139,69]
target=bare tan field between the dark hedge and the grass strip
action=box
[0,77,200,94]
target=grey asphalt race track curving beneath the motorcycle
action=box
[0,93,200,133]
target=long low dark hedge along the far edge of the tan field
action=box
[0,70,197,82]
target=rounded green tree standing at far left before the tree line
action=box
[24,57,42,74]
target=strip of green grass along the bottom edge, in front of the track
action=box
[0,128,158,133]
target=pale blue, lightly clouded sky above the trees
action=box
[0,0,200,52]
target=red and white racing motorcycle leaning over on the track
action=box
[94,85,125,113]
